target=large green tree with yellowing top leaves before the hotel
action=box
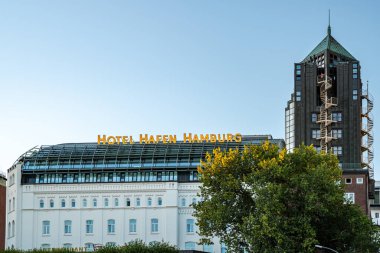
[194,142,379,253]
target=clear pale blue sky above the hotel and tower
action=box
[0,0,380,179]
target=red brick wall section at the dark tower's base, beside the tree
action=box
[343,171,369,215]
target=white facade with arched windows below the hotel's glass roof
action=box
[6,164,224,253]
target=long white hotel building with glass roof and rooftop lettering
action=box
[6,134,285,253]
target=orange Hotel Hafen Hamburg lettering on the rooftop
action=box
[98,133,242,145]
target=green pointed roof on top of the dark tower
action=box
[302,26,356,62]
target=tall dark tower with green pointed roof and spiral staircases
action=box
[285,25,374,214]
